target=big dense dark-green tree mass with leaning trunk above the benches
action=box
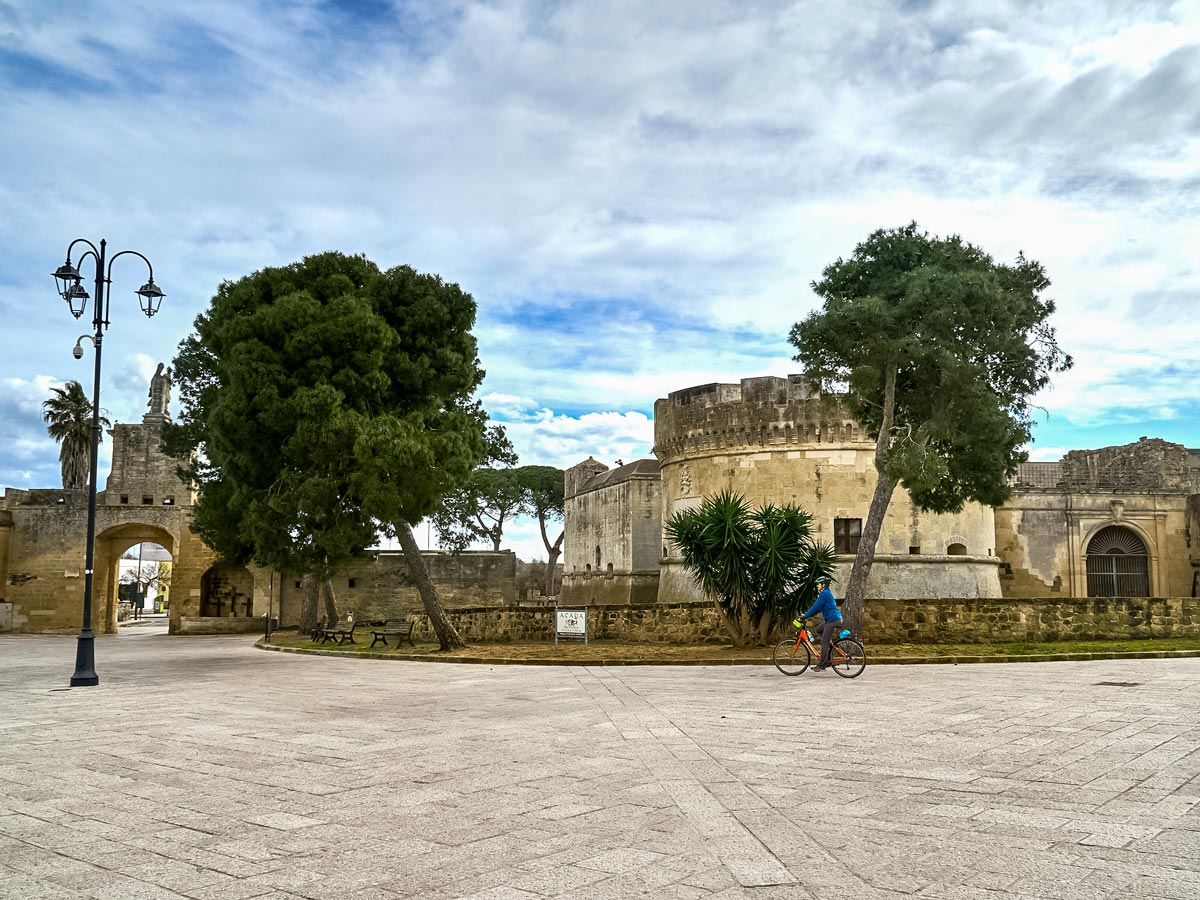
[164,253,484,649]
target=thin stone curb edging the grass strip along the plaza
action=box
[254,637,1200,666]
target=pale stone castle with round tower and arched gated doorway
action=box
[562,376,1200,604]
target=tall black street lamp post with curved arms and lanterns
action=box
[54,238,164,688]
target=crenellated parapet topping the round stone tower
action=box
[654,374,874,462]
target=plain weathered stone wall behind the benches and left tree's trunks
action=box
[278,550,516,625]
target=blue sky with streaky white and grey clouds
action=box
[0,0,1200,559]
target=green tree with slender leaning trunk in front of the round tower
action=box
[791,222,1072,628]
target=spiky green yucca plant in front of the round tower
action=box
[667,491,834,647]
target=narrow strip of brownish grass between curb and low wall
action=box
[271,631,1200,664]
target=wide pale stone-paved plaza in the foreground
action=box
[0,625,1200,900]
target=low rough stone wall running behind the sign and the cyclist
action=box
[396,598,1200,644]
